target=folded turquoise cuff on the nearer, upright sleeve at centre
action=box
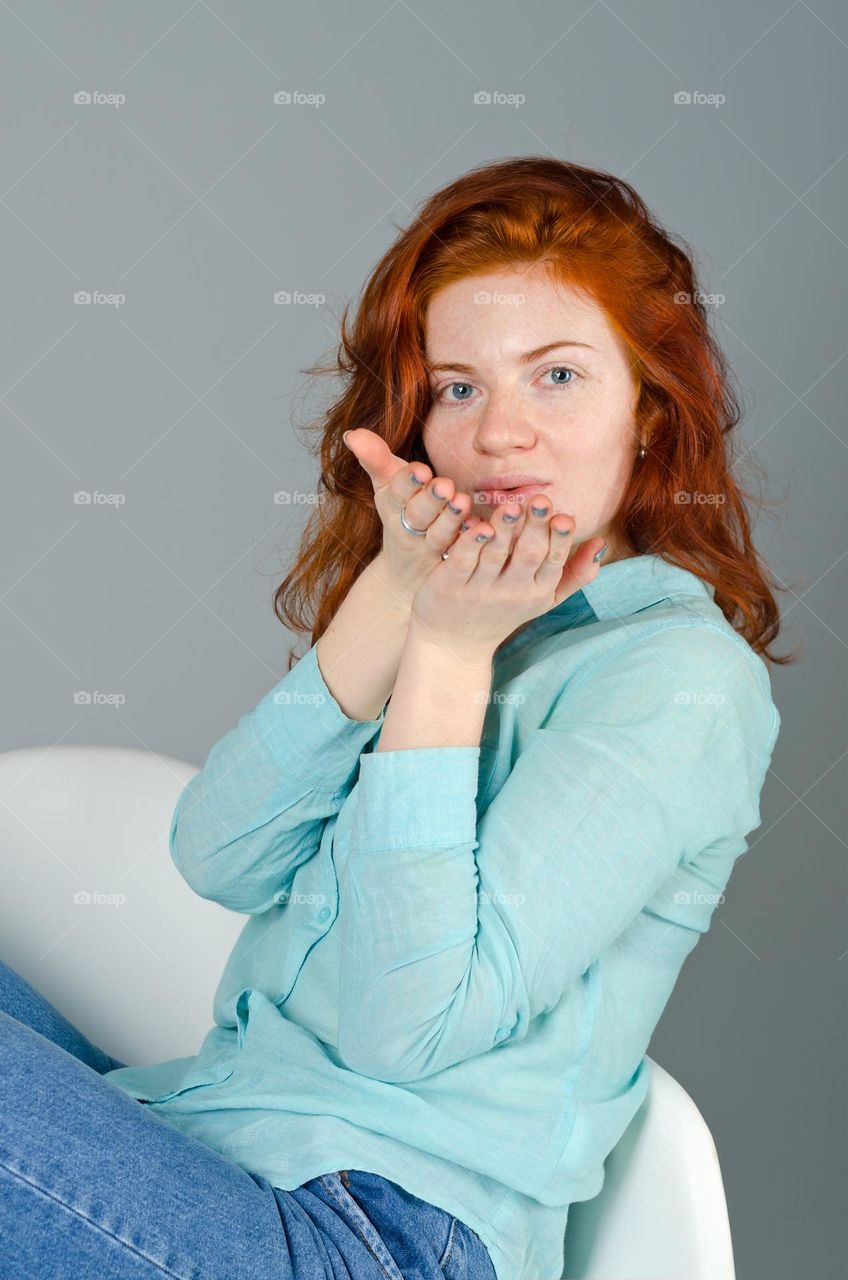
[350,746,480,850]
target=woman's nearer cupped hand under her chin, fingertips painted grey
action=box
[411,494,605,659]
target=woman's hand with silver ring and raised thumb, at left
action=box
[345,426,479,598]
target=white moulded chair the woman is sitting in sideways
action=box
[0,746,734,1280]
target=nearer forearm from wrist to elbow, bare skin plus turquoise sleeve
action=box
[337,620,502,1082]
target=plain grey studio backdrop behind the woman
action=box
[0,0,848,1280]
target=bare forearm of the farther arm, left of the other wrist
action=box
[318,556,415,721]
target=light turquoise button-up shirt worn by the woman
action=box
[106,556,780,1280]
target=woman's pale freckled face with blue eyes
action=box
[424,266,648,564]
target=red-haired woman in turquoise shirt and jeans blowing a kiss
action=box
[4,156,789,1280]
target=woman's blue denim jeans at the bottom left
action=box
[0,961,496,1280]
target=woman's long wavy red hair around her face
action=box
[274,156,795,668]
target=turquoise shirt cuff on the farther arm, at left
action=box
[251,641,388,788]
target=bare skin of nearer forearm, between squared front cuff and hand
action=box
[377,620,493,751]
